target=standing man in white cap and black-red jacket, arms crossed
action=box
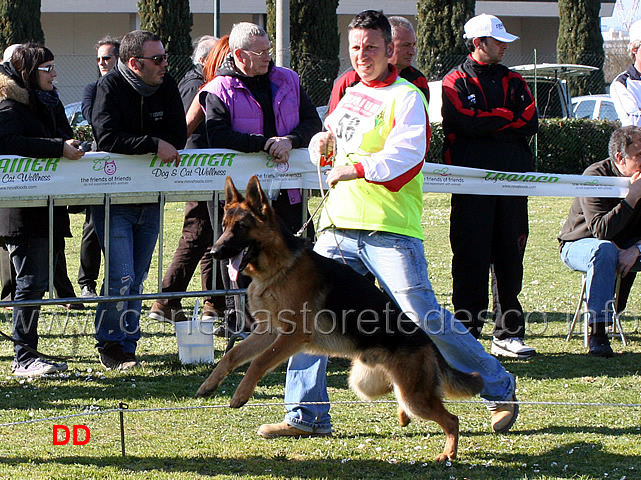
[442,14,538,358]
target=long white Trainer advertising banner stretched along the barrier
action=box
[0,149,629,201]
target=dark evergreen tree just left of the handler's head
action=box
[267,0,340,105]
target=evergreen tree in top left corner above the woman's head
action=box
[0,0,45,51]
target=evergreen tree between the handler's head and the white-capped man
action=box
[416,0,476,80]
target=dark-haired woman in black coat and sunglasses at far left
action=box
[0,44,84,376]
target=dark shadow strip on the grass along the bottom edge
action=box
[0,437,641,480]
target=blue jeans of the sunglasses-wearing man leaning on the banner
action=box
[91,203,160,353]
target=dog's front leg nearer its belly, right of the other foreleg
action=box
[229,334,308,408]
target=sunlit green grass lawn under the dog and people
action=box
[0,194,641,480]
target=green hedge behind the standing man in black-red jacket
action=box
[427,118,619,174]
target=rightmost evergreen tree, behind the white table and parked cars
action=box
[556,0,605,95]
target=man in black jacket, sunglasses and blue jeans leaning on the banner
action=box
[91,30,187,370]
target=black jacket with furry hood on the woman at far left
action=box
[0,64,73,238]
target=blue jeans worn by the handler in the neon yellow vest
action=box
[285,230,515,433]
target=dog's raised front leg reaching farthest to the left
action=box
[197,331,276,397]
